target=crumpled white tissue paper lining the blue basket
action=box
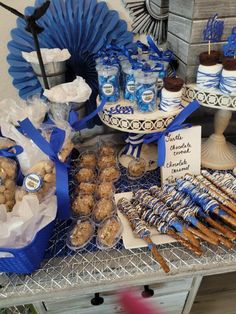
[0,195,57,258]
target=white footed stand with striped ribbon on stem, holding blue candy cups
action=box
[99,99,183,171]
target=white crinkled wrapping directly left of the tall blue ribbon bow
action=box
[0,121,48,175]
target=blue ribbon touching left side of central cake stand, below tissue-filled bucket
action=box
[69,99,106,131]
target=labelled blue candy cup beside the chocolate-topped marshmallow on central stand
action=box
[135,70,157,112]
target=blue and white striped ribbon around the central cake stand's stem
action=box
[122,133,144,159]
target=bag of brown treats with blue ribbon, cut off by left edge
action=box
[0,138,23,212]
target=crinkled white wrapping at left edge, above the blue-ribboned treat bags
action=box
[0,96,48,128]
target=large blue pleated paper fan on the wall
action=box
[7,0,133,127]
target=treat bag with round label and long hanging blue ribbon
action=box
[19,119,71,220]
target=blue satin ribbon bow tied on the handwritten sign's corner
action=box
[143,100,200,167]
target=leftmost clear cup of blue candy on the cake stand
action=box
[96,65,120,102]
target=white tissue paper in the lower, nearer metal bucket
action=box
[44,76,92,103]
